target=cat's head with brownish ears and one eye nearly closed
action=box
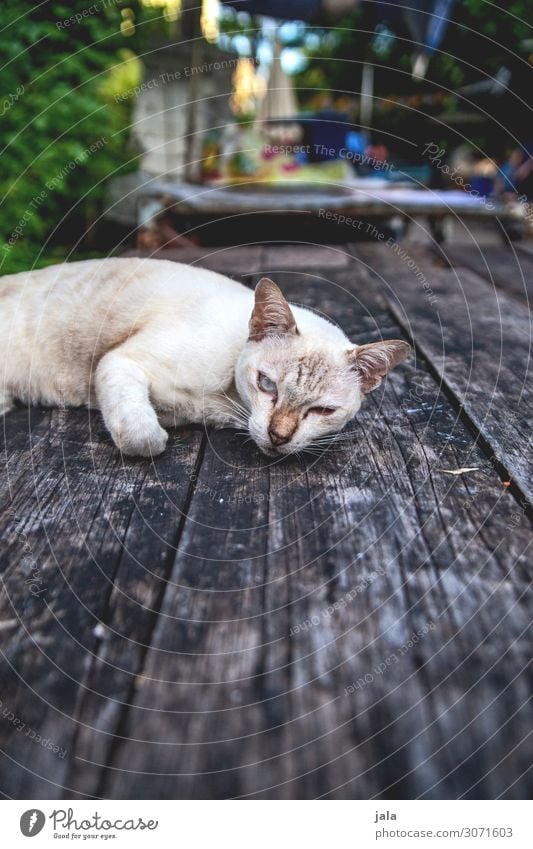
[235,278,410,456]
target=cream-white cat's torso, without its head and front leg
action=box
[0,259,253,421]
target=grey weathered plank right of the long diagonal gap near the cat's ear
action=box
[354,244,533,510]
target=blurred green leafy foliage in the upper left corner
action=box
[0,0,139,273]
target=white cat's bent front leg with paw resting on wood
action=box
[95,349,168,457]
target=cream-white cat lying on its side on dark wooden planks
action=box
[0,258,410,457]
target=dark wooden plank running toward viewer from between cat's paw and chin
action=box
[67,431,268,798]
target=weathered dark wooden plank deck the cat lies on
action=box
[0,238,533,799]
